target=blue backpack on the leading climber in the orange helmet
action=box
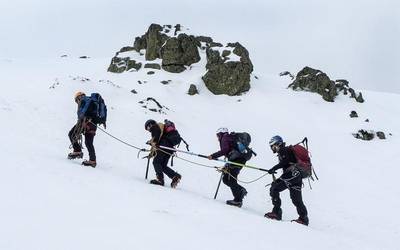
[78,93,107,125]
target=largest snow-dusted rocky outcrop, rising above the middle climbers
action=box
[108,24,253,96]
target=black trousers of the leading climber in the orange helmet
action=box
[68,123,97,161]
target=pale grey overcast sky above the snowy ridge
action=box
[0,0,400,93]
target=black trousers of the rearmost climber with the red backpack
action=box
[270,170,307,218]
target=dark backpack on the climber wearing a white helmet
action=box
[229,132,257,161]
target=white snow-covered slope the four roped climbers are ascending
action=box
[0,57,400,250]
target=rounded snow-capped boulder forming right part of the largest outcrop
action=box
[202,43,253,96]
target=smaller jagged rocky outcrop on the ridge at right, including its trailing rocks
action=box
[288,67,364,102]
